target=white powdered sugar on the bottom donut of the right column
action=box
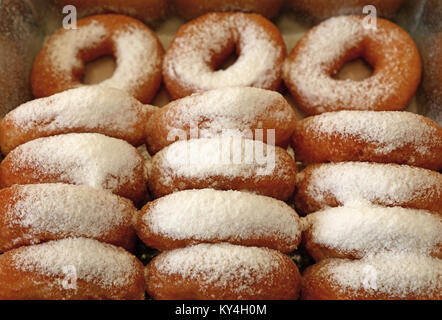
[321,253,442,298]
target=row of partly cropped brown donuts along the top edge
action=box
[55,0,403,24]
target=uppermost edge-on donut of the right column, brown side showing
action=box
[293,111,442,171]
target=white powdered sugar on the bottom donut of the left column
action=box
[12,238,138,288]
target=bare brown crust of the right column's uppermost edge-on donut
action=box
[292,111,442,171]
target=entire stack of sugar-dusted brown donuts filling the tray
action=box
[0,0,442,300]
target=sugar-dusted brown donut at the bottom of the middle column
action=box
[145,243,301,300]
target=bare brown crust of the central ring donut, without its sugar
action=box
[163,12,286,100]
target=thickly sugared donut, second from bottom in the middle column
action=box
[136,189,301,253]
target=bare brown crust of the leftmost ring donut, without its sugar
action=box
[31,14,164,103]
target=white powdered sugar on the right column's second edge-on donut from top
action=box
[297,162,442,206]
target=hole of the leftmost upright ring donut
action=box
[81,55,117,85]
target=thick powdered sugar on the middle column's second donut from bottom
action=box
[143,189,301,243]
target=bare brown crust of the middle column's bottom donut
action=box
[145,248,301,300]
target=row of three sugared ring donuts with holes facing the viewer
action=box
[31,12,422,115]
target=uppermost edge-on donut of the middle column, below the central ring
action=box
[146,87,296,154]
